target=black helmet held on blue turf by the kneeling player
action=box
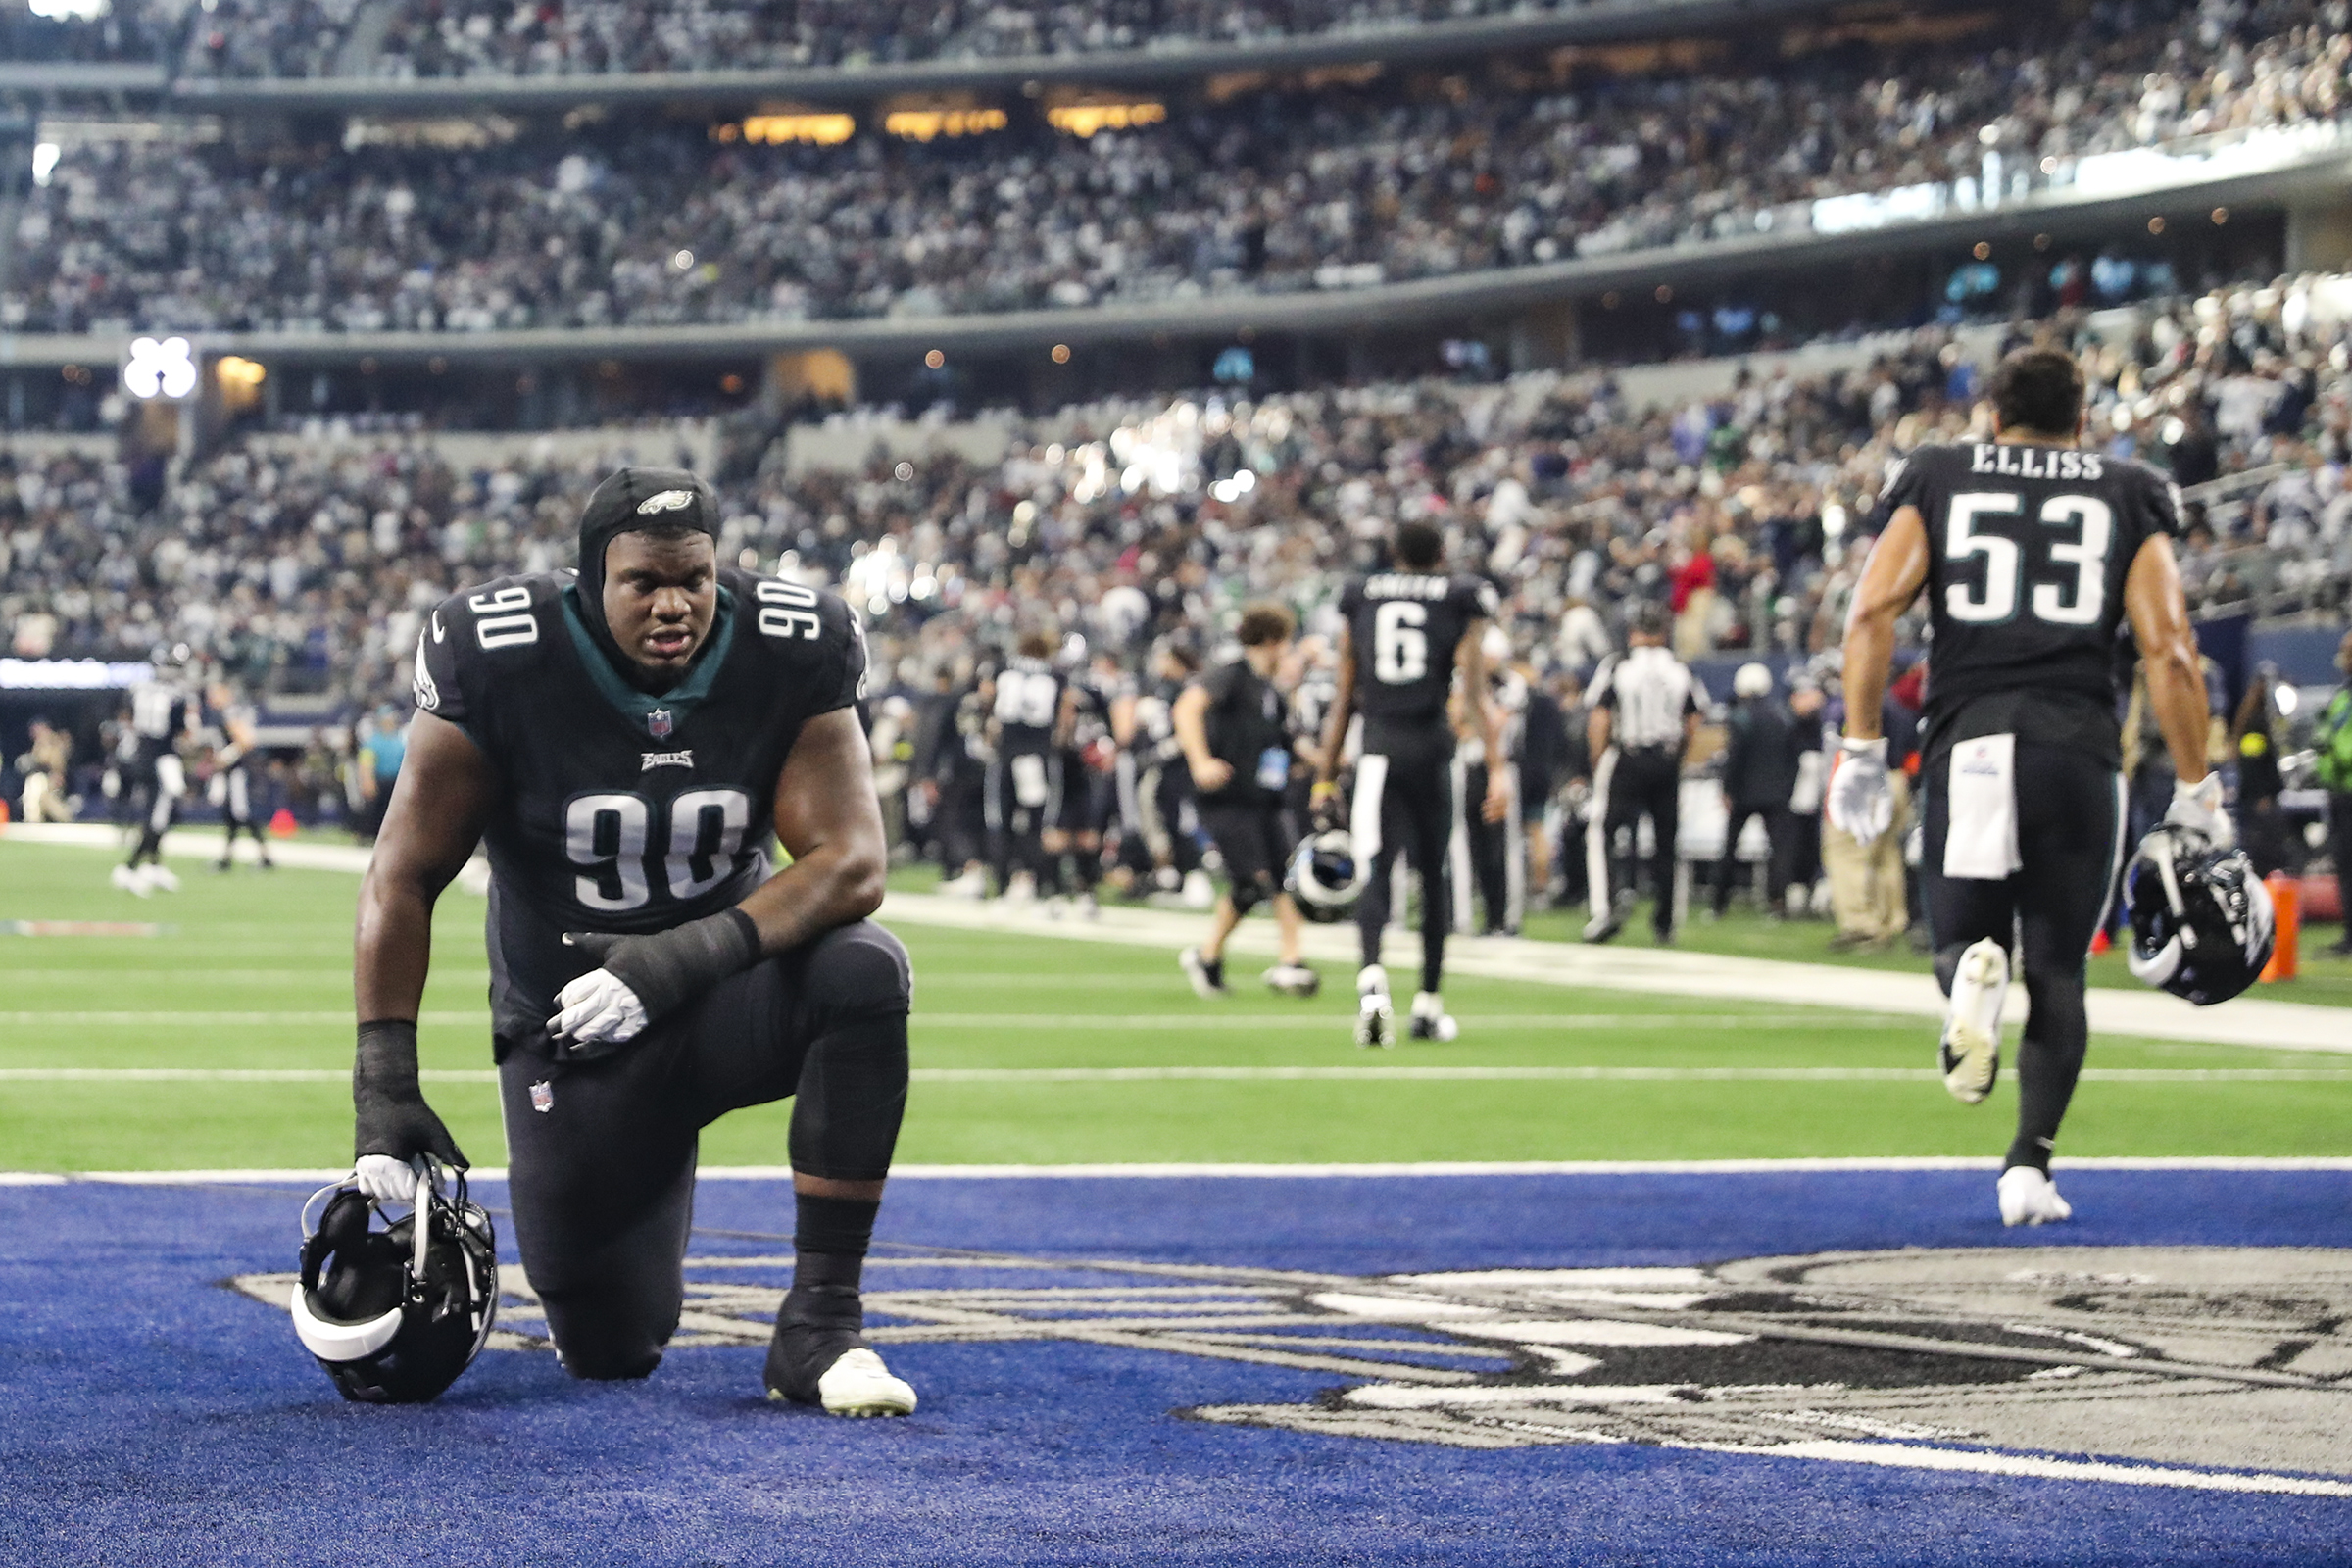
[289,1173,499,1405]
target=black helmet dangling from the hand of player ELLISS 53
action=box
[2124,827,2272,1006]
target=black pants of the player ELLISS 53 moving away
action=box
[1919,738,2124,1171]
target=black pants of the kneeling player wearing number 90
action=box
[499,921,912,1378]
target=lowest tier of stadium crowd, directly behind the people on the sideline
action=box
[0,279,2352,706]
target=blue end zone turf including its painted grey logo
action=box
[0,1171,2352,1566]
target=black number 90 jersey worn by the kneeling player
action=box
[416,566,865,1057]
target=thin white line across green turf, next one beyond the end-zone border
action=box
[18,1065,2352,1084]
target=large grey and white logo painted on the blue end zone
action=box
[230,1246,2352,1497]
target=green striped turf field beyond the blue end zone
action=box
[0,842,2352,1171]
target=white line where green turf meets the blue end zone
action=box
[27,1154,2352,1187]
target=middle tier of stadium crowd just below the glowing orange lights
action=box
[18,0,2352,331]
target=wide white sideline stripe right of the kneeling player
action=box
[882,894,2352,1054]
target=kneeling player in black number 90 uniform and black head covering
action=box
[353,467,915,1415]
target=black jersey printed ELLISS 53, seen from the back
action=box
[1880,442,2180,726]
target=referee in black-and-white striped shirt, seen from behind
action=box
[1586,604,1705,948]
